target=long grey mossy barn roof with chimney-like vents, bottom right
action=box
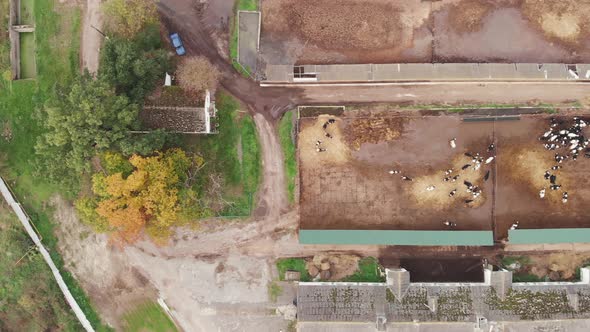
[297,265,590,331]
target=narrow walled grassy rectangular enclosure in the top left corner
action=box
[8,0,37,80]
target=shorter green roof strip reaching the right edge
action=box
[508,228,590,244]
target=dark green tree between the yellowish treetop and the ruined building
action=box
[99,25,171,102]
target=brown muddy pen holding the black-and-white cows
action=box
[298,109,590,241]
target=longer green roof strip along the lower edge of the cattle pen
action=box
[299,229,494,246]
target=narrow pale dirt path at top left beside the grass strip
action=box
[80,0,103,74]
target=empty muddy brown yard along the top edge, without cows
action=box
[260,0,590,64]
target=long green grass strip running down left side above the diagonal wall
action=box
[0,1,108,331]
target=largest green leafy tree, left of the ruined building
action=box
[35,74,139,184]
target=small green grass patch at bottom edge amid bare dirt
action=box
[123,302,178,332]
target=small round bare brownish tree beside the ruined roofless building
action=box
[176,56,220,93]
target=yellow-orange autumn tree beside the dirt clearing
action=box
[93,149,195,243]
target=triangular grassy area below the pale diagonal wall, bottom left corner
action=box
[0,205,82,331]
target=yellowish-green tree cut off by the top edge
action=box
[103,0,158,38]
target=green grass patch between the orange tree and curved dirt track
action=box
[183,93,261,216]
